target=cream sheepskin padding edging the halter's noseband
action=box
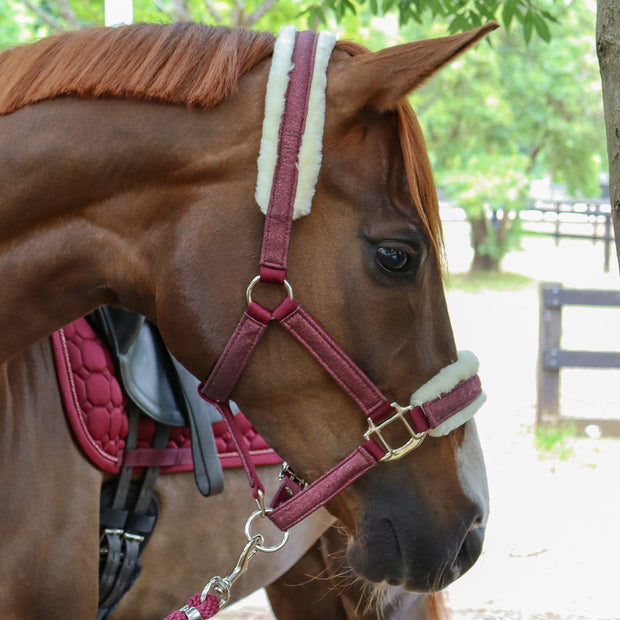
[410,351,487,437]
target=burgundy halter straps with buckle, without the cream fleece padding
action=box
[201,31,482,530]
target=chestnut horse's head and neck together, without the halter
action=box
[0,25,493,591]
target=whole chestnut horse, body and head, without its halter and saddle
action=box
[0,24,494,620]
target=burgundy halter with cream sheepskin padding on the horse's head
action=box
[168,26,485,618]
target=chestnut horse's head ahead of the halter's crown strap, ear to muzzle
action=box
[160,28,488,591]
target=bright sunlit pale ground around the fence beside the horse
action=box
[221,222,620,620]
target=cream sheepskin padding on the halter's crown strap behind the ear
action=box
[255,26,336,219]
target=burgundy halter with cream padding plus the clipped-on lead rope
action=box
[166,27,483,620]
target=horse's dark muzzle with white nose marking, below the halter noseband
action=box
[347,421,489,592]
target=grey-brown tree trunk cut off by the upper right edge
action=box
[596,0,620,274]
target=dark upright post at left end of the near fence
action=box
[536,282,562,426]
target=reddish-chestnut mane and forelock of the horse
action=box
[0,23,443,264]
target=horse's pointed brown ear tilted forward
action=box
[327,22,499,113]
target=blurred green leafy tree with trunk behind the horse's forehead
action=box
[406,0,605,270]
